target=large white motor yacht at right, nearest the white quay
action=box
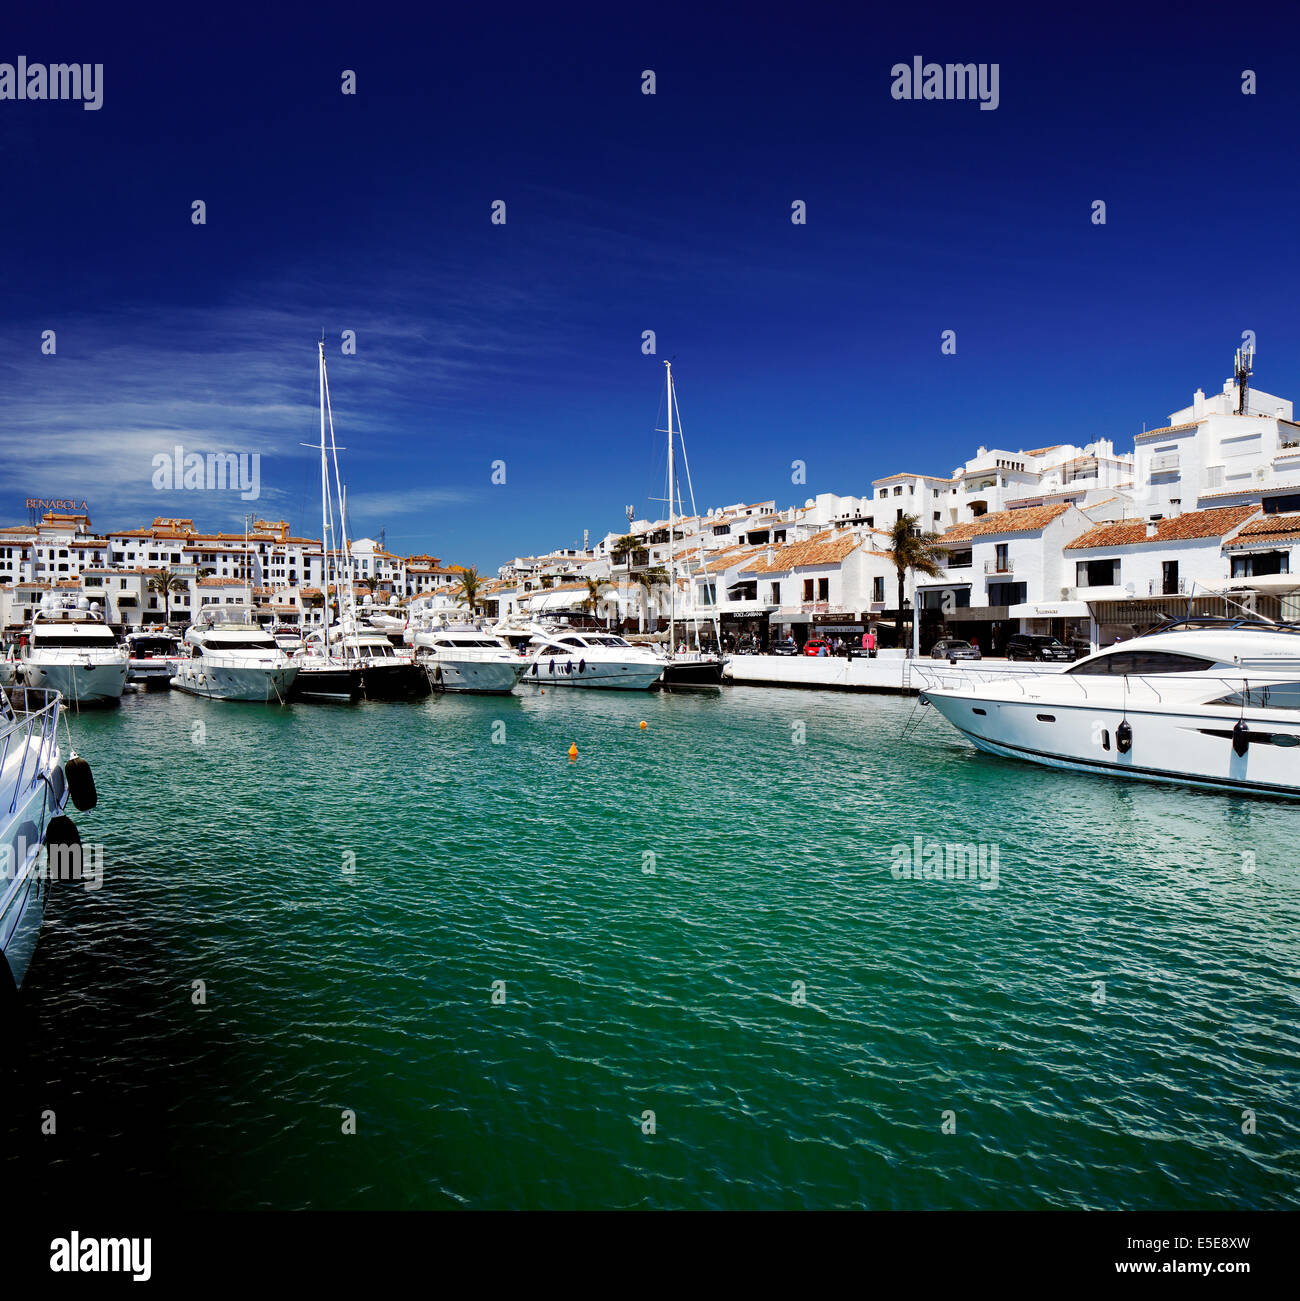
[912,618,1300,796]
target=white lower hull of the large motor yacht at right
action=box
[924,688,1300,799]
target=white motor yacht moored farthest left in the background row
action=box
[21,596,129,708]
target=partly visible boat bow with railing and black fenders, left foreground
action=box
[0,687,95,988]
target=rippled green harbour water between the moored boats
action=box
[0,688,1300,1209]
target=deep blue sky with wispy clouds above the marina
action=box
[0,4,1300,569]
